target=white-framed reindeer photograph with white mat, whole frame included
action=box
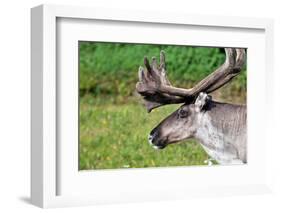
[31,5,273,207]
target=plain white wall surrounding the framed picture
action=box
[0,0,281,212]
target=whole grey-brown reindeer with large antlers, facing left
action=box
[136,48,247,164]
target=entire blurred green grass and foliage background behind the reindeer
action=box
[79,41,247,170]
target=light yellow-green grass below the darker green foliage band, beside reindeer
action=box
[77,96,208,170]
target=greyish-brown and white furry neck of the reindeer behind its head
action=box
[194,101,245,163]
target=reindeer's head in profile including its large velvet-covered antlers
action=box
[136,48,245,149]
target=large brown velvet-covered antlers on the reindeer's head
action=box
[136,48,245,112]
